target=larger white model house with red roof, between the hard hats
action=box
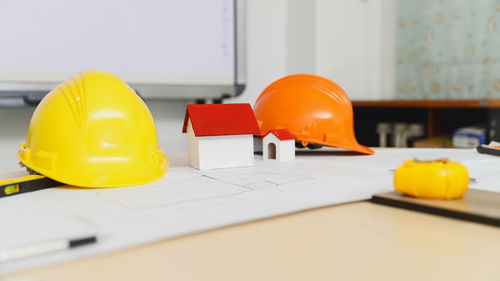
[182,103,259,170]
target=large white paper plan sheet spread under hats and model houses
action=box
[0,149,500,272]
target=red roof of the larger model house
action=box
[182,103,260,137]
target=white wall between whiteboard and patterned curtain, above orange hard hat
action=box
[235,0,397,104]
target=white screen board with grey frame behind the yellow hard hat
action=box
[0,0,245,102]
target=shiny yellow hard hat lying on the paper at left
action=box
[17,71,168,188]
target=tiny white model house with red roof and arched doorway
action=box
[262,129,297,161]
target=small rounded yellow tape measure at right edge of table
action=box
[394,159,469,199]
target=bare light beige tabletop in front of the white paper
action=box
[0,201,500,281]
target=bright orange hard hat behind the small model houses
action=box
[254,74,374,154]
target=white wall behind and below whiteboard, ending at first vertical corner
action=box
[0,0,287,170]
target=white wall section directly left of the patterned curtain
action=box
[315,0,396,100]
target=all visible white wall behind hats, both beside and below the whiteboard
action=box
[0,0,396,169]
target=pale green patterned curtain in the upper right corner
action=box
[396,0,500,99]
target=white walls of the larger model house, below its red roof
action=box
[187,120,254,170]
